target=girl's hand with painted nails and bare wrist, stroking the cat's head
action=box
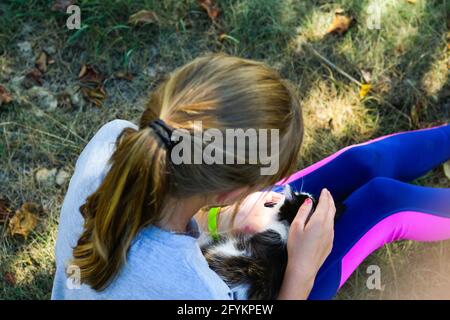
[279,189,336,299]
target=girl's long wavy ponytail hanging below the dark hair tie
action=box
[72,127,168,290]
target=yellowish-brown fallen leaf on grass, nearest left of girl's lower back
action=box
[9,202,39,238]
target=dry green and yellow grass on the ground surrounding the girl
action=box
[0,0,450,299]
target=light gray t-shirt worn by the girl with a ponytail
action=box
[52,120,233,299]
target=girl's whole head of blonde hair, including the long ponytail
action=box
[72,54,303,290]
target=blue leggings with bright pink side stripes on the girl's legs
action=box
[274,125,450,299]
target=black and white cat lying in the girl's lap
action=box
[200,187,344,300]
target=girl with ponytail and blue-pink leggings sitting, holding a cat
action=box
[53,51,450,299]
